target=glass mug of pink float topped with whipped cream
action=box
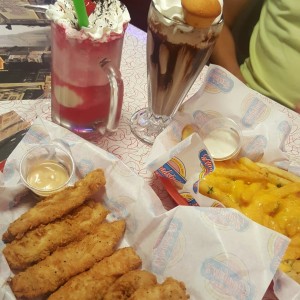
[46,0,130,136]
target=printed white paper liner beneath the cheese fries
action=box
[146,65,300,299]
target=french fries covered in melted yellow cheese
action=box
[199,157,300,283]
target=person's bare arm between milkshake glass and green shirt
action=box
[210,0,251,82]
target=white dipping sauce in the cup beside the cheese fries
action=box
[203,128,240,160]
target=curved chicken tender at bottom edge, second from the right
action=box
[103,270,157,300]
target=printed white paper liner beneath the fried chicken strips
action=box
[0,118,298,300]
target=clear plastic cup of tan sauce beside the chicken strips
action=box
[20,144,74,197]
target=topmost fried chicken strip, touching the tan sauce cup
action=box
[2,169,105,242]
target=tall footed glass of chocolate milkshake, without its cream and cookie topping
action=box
[131,1,223,144]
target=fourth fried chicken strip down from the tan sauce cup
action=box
[48,247,142,300]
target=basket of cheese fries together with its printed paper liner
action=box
[147,65,300,299]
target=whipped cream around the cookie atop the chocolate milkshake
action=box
[153,0,223,24]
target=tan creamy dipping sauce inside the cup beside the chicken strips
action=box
[26,160,69,191]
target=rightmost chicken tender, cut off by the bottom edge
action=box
[129,277,189,300]
